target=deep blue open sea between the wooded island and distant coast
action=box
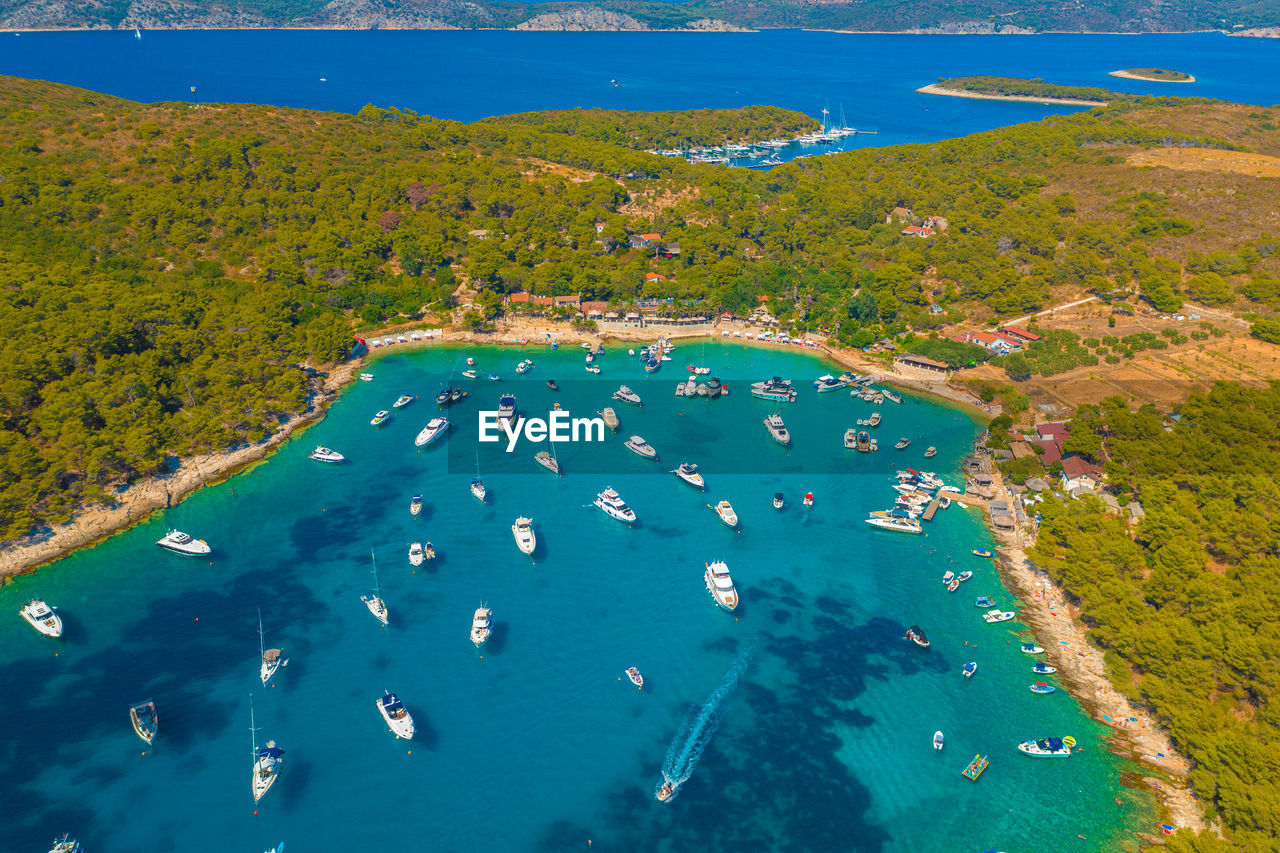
[0,29,1280,146]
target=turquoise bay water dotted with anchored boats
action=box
[0,343,1151,853]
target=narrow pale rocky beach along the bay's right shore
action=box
[988,475,1208,843]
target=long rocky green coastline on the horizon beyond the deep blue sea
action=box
[0,0,1280,35]
